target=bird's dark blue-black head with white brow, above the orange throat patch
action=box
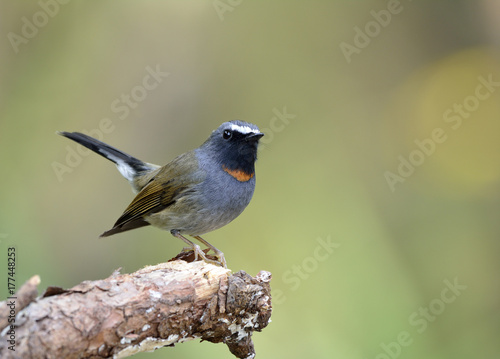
[207,121,263,174]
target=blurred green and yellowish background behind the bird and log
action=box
[0,0,500,359]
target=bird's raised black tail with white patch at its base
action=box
[57,132,159,184]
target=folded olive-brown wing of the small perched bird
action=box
[101,152,204,237]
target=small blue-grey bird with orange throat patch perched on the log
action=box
[57,121,264,267]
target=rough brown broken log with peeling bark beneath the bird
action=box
[0,260,271,359]
